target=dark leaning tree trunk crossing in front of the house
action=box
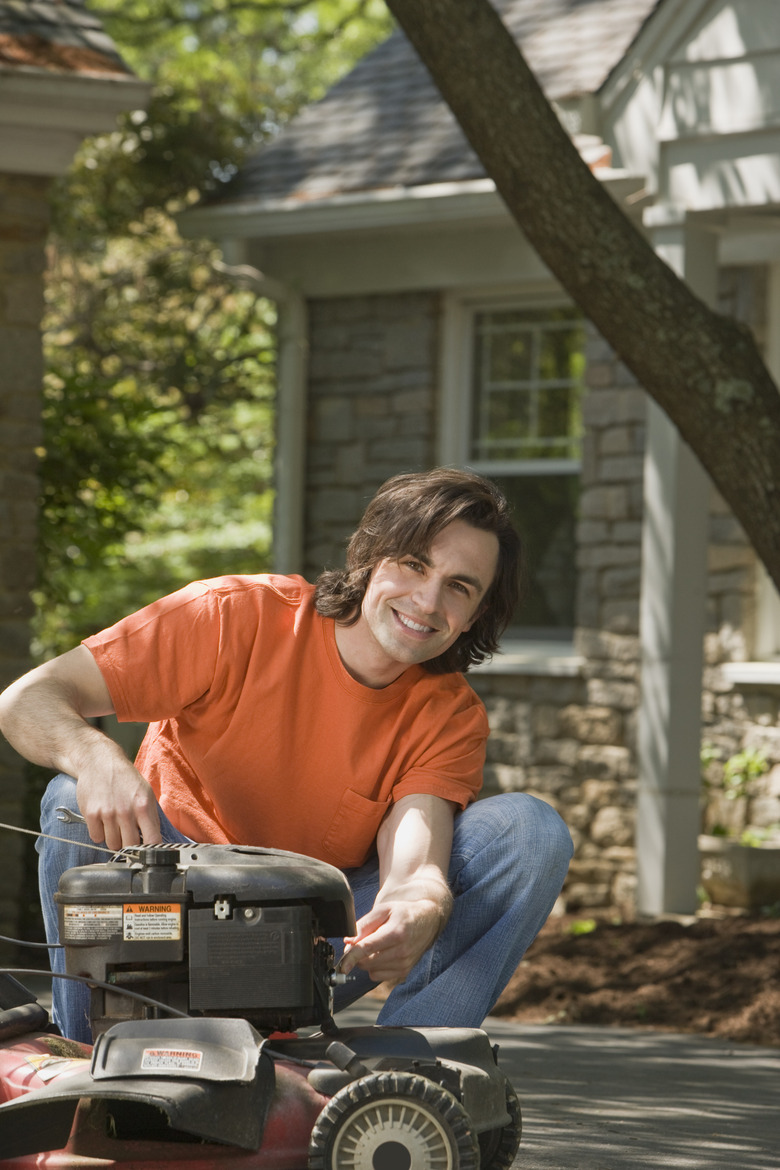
[387,0,780,590]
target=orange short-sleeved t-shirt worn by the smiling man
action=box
[84,576,488,868]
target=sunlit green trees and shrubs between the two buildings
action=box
[35,0,389,658]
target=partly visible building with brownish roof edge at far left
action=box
[0,0,149,931]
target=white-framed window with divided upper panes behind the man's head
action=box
[446,292,585,641]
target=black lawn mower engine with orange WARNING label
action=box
[55,845,356,1037]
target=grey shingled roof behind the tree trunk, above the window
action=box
[216,0,663,204]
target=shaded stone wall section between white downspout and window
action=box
[304,293,440,580]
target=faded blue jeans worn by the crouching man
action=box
[36,776,572,1042]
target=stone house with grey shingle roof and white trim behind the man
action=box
[182,0,780,914]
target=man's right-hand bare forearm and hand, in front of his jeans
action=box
[341,796,455,983]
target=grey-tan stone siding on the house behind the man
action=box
[306,280,780,917]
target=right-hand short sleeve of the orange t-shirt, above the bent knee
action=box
[393,695,488,808]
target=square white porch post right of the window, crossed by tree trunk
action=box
[636,215,717,915]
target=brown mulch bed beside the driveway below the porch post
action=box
[493,916,780,1047]
